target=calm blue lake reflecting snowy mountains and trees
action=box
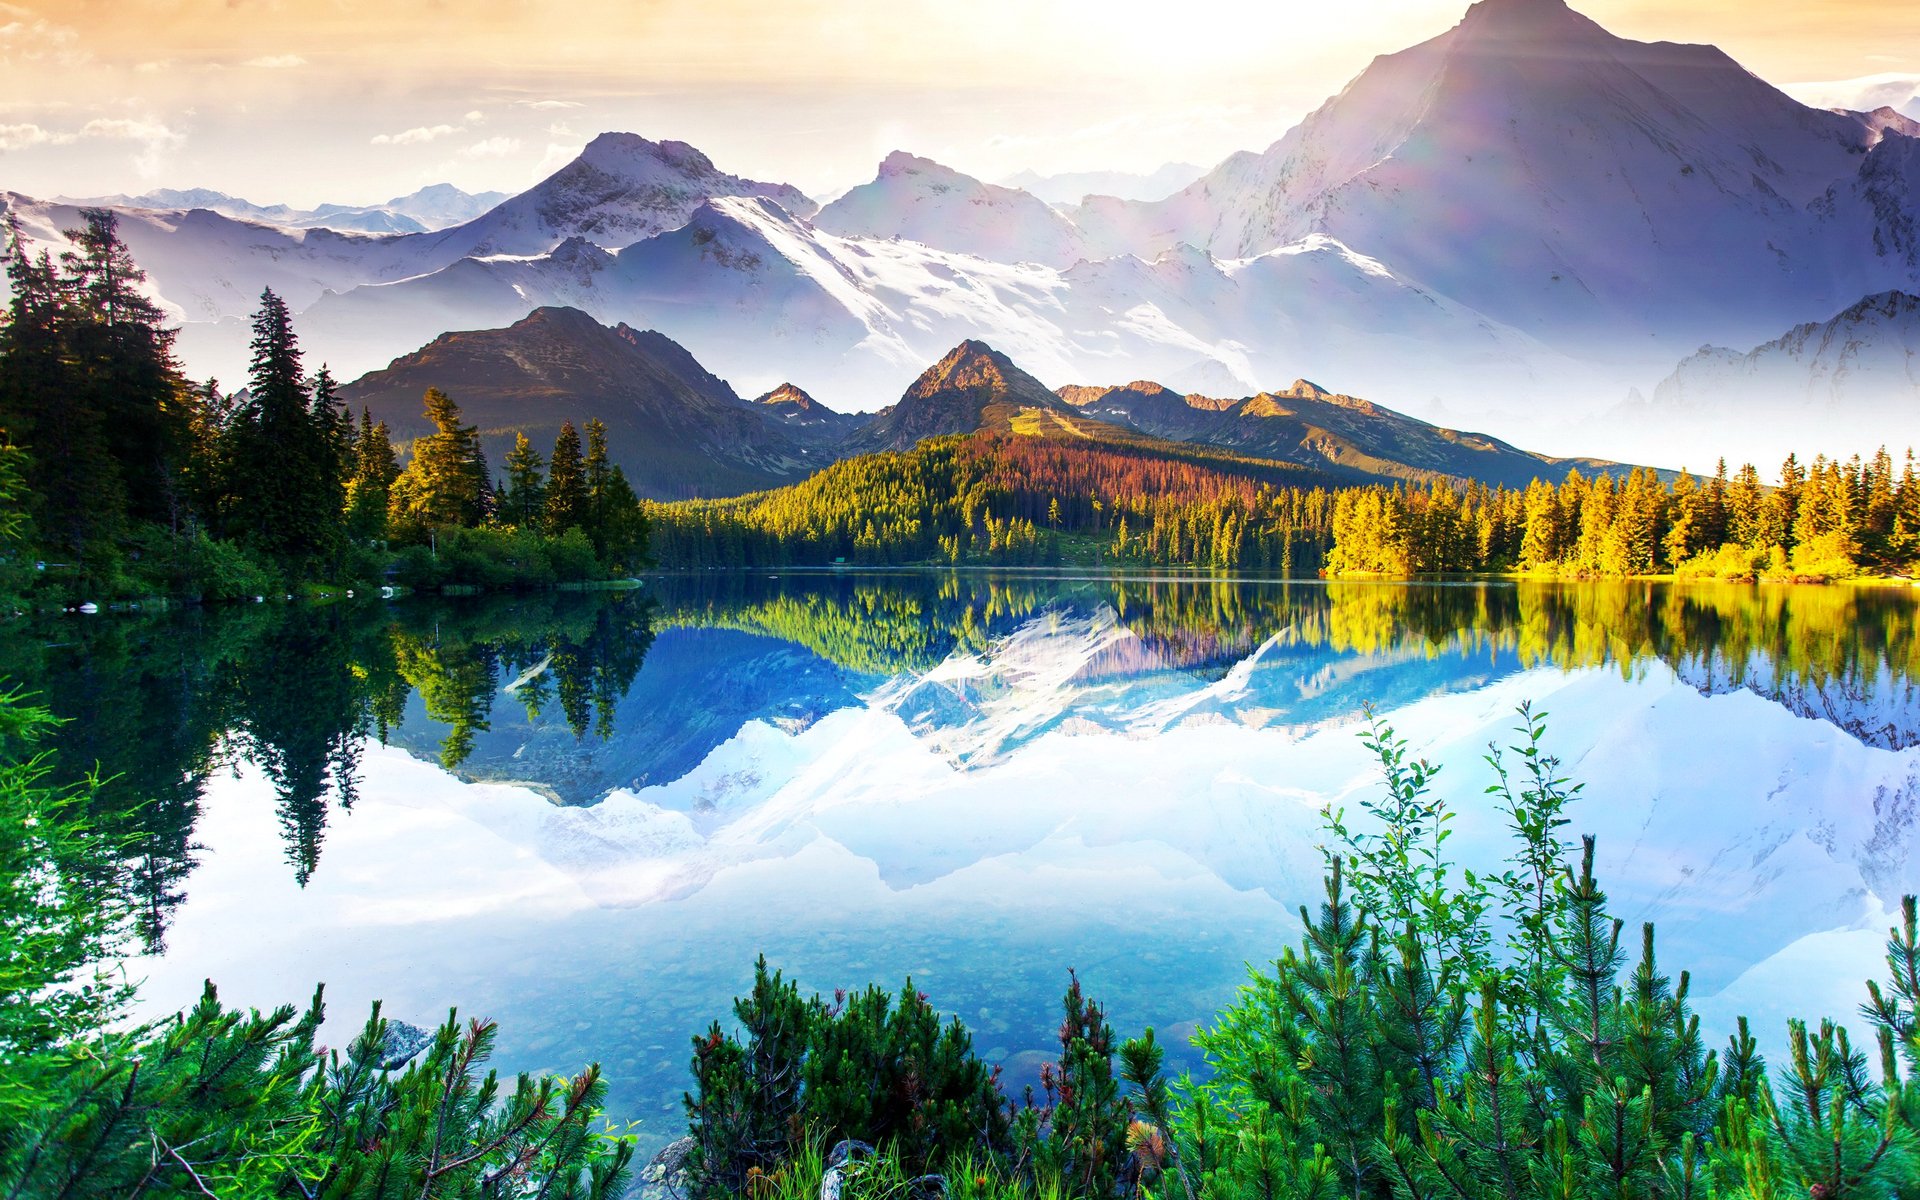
[15,572,1920,1144]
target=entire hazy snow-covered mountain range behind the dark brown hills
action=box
[6,0,1920,465]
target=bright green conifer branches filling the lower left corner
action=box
[0,693,634,1200]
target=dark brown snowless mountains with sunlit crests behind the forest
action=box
[342,307,1622,499]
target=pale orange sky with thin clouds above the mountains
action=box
[0,0,1920,205]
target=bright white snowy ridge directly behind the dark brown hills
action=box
[288,187,1574,411]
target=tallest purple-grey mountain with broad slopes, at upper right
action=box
[1077,0,1920,370]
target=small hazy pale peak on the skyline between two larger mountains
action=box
[814,150,1087,267]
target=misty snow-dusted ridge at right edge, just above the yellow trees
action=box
[1649,292,1920,465]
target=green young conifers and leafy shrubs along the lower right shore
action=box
[687,708,1920,1200]
